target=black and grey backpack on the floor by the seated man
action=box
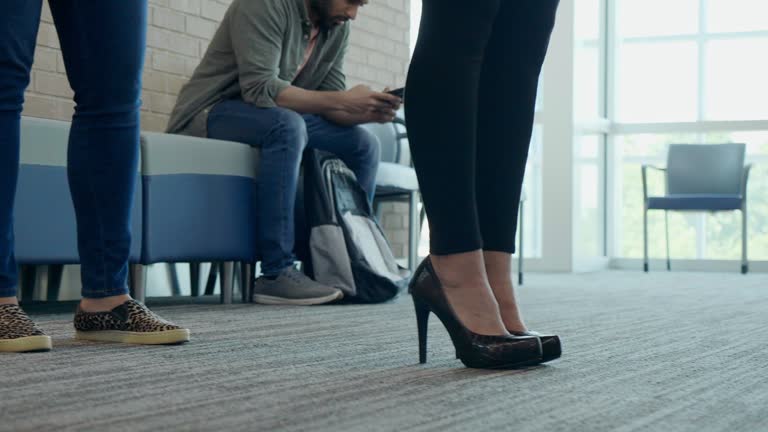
[296,149,410,303]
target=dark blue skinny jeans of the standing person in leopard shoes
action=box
[0,0,147,298]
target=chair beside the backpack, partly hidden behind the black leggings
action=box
[363,117,421,271]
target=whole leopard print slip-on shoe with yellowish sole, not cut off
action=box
[75,299,189,345]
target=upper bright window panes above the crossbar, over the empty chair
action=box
[614,0,768,123]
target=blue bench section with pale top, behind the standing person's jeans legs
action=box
[13,117,141,264]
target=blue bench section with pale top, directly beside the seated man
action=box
[142,133,258,264]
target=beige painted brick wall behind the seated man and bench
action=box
[23,0,411,256]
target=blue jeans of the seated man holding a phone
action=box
[208,100,380,276]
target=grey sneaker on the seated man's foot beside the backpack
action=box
[253,267,344,306]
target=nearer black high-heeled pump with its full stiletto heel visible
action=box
[408,257,542,369]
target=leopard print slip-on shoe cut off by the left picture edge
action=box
[0,305,51,352]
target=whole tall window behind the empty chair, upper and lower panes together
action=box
[608,0,768,260]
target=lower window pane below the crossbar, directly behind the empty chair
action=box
[615,131,768,260]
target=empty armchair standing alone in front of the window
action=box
[642,144,751,273]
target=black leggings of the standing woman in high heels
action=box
[405,0,558,255]
